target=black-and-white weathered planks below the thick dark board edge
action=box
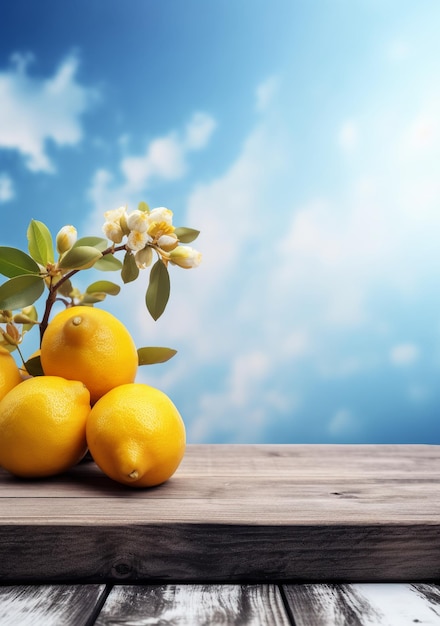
[0,583,440,626]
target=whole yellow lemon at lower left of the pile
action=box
[0,376,90,477]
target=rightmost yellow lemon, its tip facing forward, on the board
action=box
[86,383,186,487]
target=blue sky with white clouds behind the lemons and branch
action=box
[0,0,440,443]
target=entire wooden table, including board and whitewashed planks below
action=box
[0,445,440,626]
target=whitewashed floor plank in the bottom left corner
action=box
[0,585,105,626]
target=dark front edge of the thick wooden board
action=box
[0,524,440,583]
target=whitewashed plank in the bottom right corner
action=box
[284,583,440,626]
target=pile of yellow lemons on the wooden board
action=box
[0,306,186,487]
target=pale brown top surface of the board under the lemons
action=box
[0,446,440,525]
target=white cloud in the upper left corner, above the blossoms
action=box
[0,53,97,172]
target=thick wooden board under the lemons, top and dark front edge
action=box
[0,445,440,585]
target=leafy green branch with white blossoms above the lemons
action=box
[0,202,201,365]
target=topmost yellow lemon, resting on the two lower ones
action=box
[41,306,138,404]
